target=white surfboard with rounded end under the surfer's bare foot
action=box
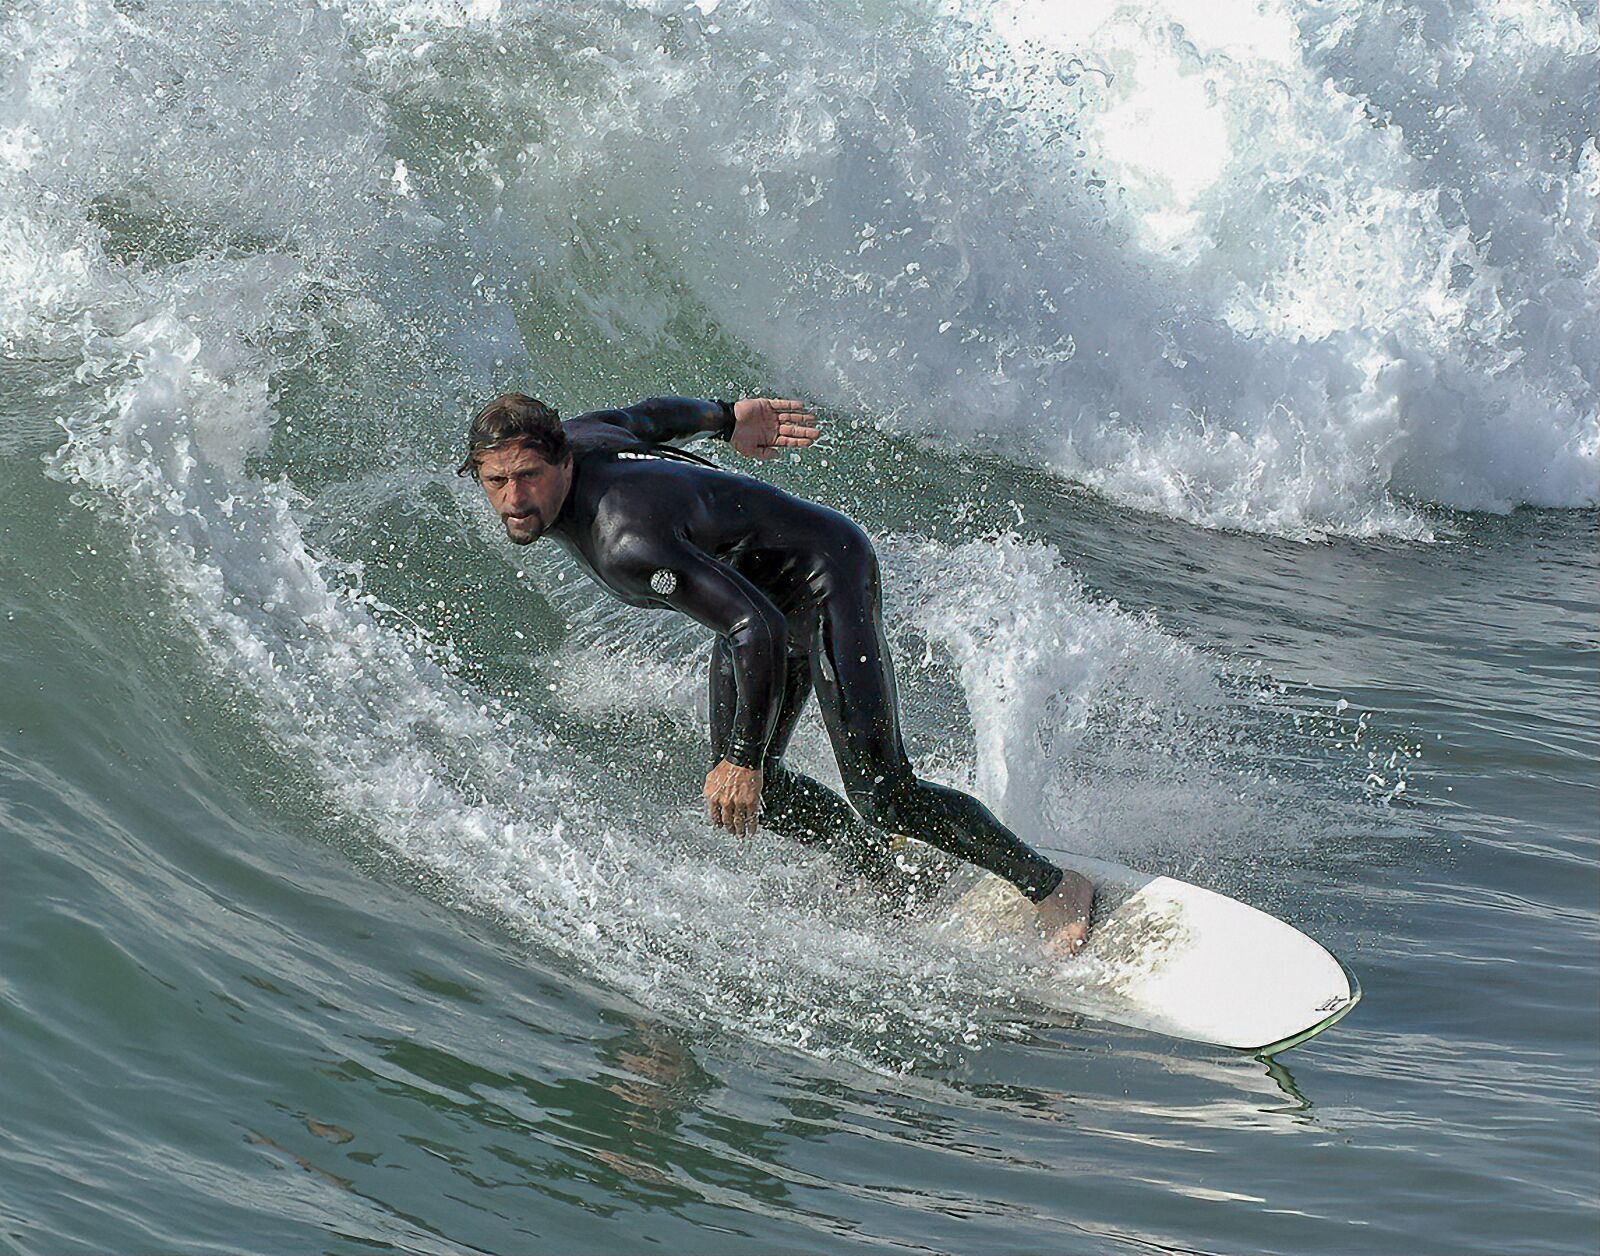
[941,856,1362,1054]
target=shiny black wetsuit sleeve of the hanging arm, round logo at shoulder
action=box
[614,544,789,768]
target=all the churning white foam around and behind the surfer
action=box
[0,0,1568,1061]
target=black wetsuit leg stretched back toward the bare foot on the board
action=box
[813,538,1061,902]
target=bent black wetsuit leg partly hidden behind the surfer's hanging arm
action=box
[710,637,898,885]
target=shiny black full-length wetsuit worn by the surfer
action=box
[549,397,1061,901]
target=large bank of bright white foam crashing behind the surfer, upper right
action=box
[340,0,1600,536]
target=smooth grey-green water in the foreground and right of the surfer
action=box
[0,419,1600,1251]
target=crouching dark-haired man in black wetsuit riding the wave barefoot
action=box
[459,392,1093,950]
